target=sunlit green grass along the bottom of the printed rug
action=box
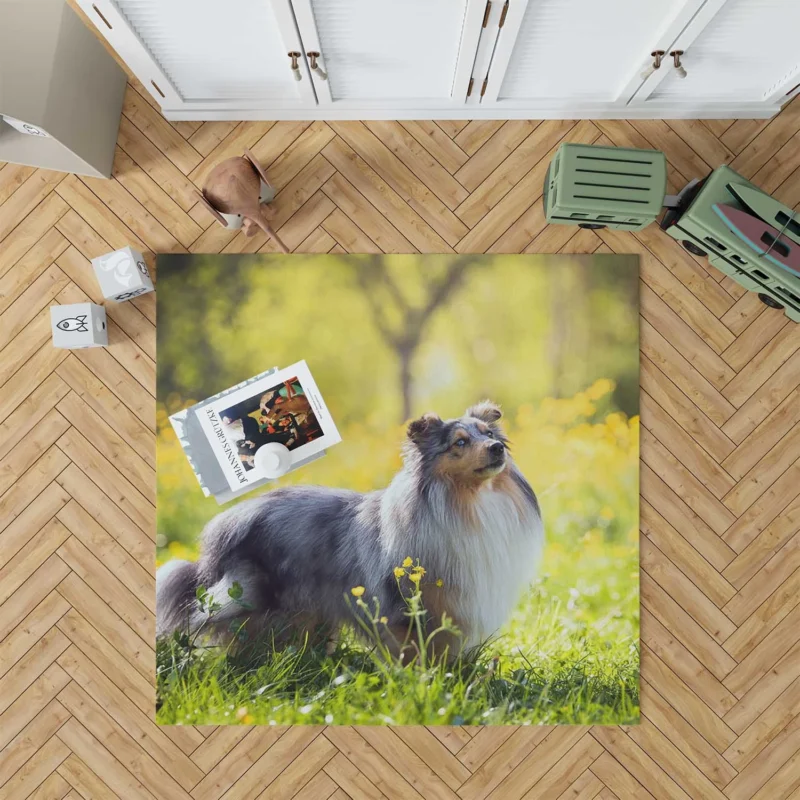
[157,533,639,725]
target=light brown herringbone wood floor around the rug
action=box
[0,69,800,800]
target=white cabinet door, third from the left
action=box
[476,0,702,111]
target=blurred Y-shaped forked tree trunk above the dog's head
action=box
[355,255,476,422]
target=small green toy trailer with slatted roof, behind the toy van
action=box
[544,144,667,231]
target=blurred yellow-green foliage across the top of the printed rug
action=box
[158,255,639,418]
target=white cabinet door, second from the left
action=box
[292,0,487,110]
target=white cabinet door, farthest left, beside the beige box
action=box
[78,0,316,112]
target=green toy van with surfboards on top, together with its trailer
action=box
[543,144,800,322]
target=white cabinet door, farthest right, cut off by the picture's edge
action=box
[633,0,800,112]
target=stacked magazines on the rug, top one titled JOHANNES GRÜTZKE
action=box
[170,361,342,503]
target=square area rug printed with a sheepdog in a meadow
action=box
[156,254,639,725]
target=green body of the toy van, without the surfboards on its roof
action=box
[661,166,800,322]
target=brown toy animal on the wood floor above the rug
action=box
[198,150,289,253]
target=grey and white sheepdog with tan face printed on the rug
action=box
[156,401,544,655]
